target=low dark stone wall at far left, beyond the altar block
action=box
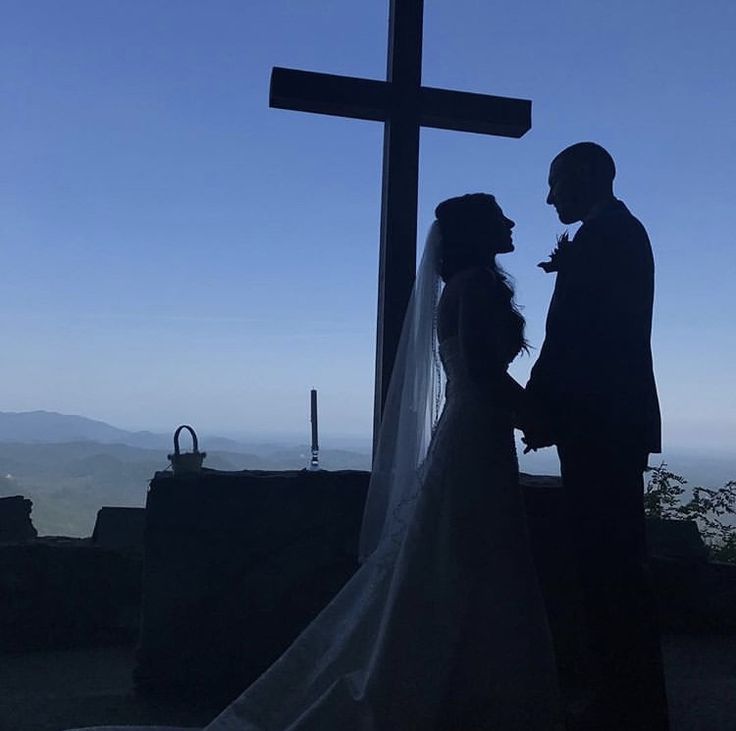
[0,496,144,652]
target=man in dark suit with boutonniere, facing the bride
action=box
[525,142,668,731]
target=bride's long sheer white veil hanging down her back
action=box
[360,221,444,563]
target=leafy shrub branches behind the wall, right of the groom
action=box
[644,462,736,563]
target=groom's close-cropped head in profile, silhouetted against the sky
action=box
[547,142,616,223]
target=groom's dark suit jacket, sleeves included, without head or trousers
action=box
[527,199,661,453]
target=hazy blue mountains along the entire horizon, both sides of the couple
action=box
[0,411,736,536]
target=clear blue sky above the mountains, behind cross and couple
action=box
[0,0,736,448]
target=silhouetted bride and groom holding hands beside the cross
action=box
[72,143,667,731]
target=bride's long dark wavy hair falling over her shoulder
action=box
[434,193,529,352]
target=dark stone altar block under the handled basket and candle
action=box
[135,470,369,703]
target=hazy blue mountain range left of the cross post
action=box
[0,411,370,536]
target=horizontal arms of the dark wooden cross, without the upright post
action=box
[269,67,532,137]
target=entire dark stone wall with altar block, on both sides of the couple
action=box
[7,471,736,704]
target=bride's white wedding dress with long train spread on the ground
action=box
[72,232,563,731]
